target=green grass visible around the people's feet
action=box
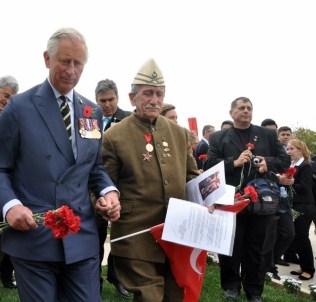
[0,263,311,302]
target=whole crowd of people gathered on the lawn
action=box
[0,28,316,302]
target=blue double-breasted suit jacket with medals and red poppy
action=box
[0,80,113,263]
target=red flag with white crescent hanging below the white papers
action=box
[150,223,207,302]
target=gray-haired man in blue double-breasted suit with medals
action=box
[0,28,121,302]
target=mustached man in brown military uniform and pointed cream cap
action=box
[103,59,199,302]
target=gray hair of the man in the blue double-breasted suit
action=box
[47,27,88,63]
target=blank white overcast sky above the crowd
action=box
[0,0,316,138]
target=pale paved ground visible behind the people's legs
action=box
[102,224,316,293]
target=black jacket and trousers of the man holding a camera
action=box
[204,125,290,296]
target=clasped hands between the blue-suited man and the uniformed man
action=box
[95,191,121,222]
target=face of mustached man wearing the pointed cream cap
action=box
[129,85,165,122]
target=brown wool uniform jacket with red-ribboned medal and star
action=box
[103,112,199,262]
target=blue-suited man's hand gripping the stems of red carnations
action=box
[6,205,38,231]
